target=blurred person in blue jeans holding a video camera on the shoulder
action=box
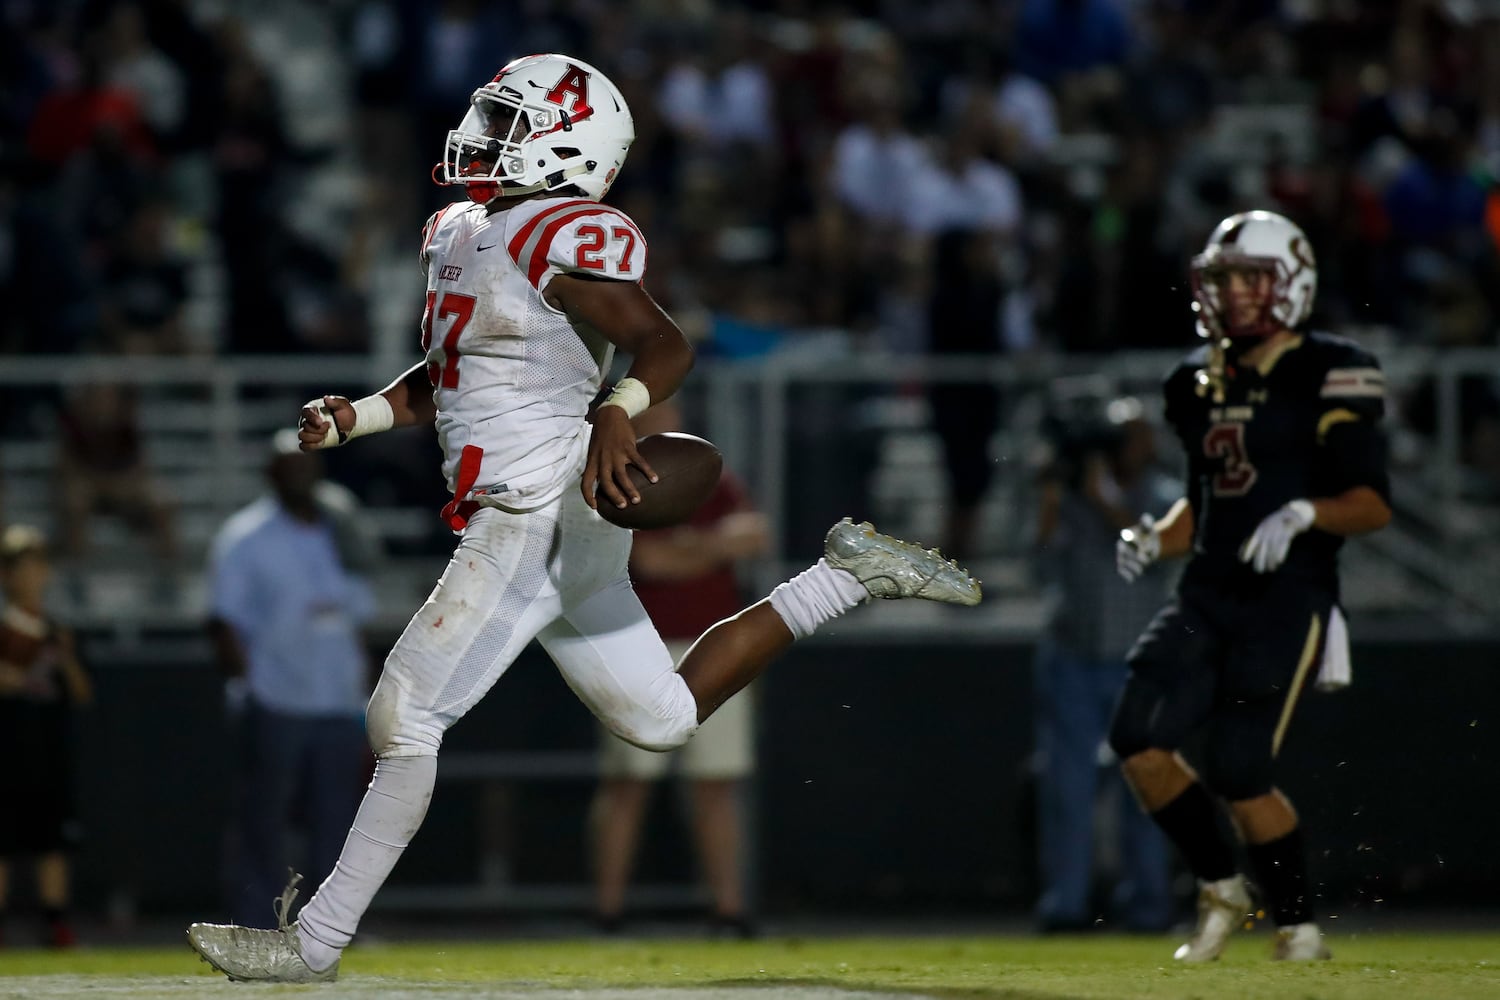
[1037,399,1182,931]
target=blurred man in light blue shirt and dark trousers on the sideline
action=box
[210,430,374,927]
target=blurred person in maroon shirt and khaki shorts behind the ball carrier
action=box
[593,402,770,937]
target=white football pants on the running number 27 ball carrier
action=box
[366,490,698,757]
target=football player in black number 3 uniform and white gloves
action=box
[1110,211,1391,961]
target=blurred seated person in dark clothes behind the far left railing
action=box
[57,382,177,571]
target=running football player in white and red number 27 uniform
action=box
[188,55,980,982]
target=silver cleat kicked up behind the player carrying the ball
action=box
[824,517,983,607]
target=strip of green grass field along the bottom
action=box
[0,933,1500,1000]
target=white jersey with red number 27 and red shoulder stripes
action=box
[422,198,647,528]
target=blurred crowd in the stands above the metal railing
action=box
[0,0,1500,550]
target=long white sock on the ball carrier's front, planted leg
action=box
[297,757,438,972]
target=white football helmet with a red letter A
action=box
[440,54,636,201]
